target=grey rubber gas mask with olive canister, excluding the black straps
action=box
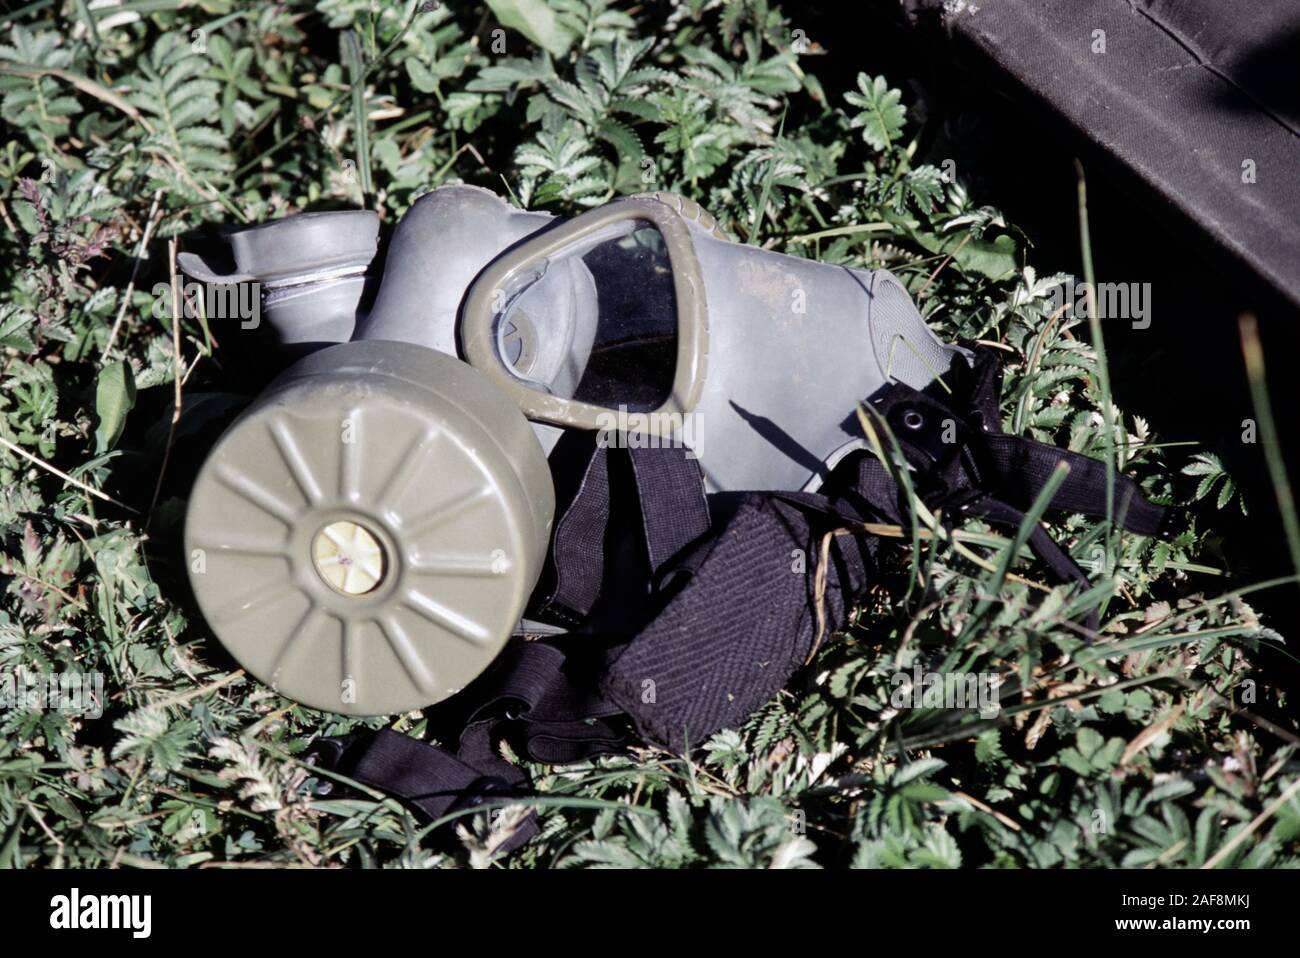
[182,186,959,715]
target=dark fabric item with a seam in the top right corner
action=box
[902,0,1300,303]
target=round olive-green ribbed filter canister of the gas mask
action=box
[186,342,555,715]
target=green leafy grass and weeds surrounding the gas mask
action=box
[0,0,1300,867]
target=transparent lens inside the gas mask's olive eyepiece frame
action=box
[493,220,677,411]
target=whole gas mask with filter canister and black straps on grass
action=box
[181,186,1166,848]
